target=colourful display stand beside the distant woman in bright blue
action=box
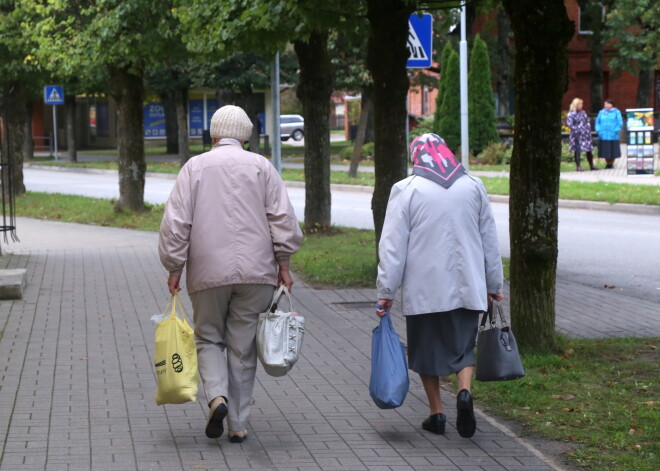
[626,108,654,176]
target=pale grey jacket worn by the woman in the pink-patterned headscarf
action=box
[377,175,504,316]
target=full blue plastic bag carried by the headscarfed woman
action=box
[369,312,410,409]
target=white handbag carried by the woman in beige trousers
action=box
[257,285,305,376]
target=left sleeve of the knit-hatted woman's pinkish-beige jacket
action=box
[158,166,193,275]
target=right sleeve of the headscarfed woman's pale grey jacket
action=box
[479,181,504,294]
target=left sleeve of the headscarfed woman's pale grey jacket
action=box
[376,185,411,299]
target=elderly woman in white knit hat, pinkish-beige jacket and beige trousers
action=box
[158,105,302,443]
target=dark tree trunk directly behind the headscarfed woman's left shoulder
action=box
[367,0,413,244]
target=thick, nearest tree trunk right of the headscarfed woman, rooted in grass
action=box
[502,0,574,350]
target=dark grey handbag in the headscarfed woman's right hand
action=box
[477,300,525,381]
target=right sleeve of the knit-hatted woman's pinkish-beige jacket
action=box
[265,163,302,266]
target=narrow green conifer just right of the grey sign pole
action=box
[468,35,499,154]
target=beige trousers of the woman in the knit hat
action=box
[190,284,275,431]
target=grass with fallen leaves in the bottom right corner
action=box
[473,338,660,471]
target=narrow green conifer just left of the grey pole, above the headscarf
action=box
[437,51,461,152]
